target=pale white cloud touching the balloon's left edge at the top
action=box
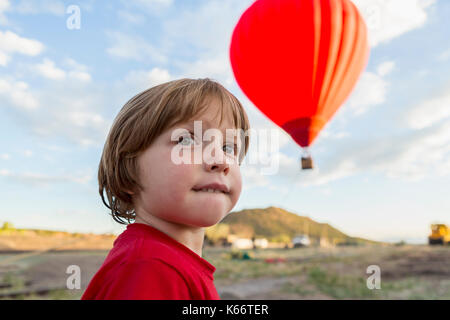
[162,0,252,86]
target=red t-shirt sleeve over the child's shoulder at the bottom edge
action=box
[103,259,192,300]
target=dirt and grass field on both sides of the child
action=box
[0,245,450,300]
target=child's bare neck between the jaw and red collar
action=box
[134,215,205,257]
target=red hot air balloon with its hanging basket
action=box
[229,0,369,169]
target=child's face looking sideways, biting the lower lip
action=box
[135,101,242,227]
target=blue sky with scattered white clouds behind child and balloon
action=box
[0,0,450,243]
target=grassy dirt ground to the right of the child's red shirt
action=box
[216,246,450,300]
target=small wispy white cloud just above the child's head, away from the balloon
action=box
[106,31,167,63]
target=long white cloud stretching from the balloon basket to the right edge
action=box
[264,82,450,186]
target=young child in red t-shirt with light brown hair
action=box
[81,79,249,300]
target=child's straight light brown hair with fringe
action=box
[98,78,250,224]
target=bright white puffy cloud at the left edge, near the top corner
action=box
[0,31,44,66]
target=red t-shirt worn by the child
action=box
[81,223,220,300]
